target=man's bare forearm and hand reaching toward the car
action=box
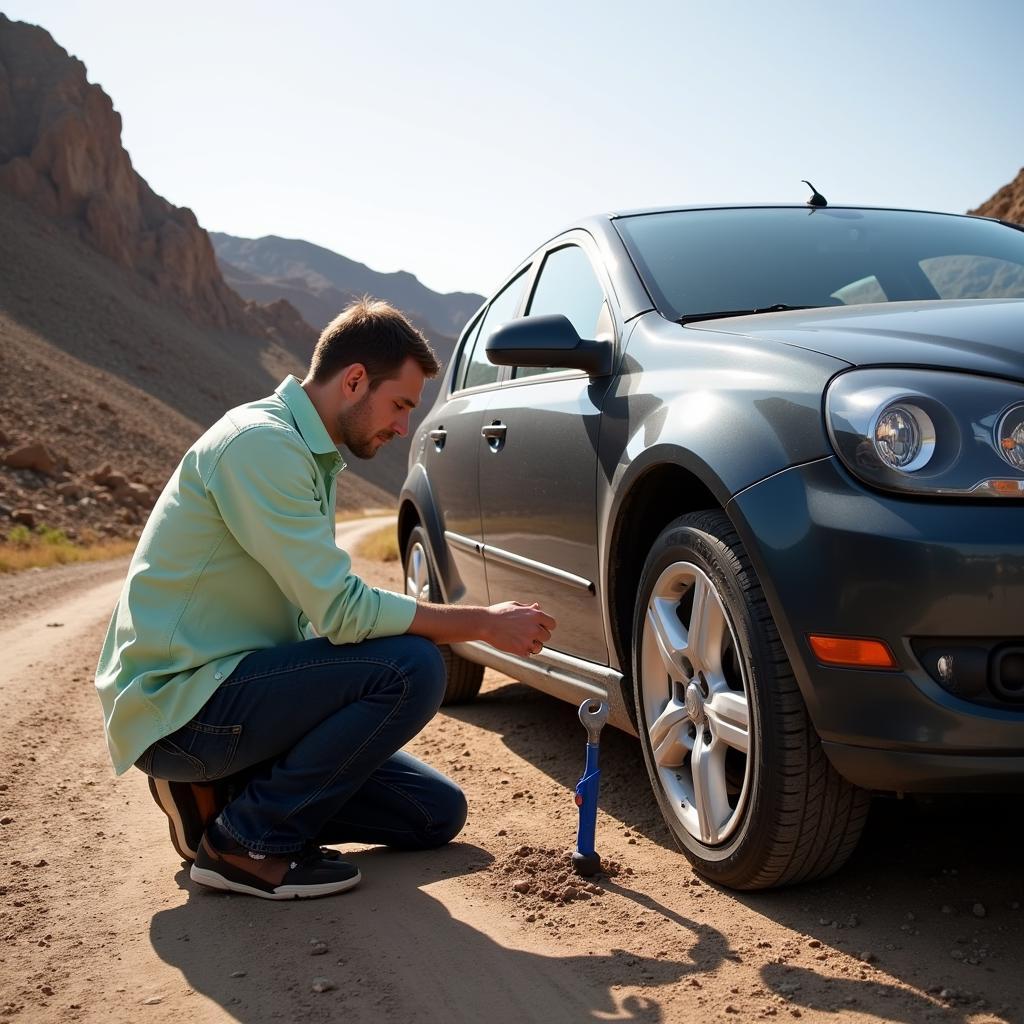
[409,601,556,657]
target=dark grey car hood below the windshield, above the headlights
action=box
[685,299,1024,380]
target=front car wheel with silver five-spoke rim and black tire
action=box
[633,510,870,890]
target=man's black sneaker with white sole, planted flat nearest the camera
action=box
[188,822,361,899]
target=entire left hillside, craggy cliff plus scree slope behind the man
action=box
[0,14,392,538]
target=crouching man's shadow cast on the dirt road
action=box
[150,843,729,1024]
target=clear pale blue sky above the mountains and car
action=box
[8,0,1024,294]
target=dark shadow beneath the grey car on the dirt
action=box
[444,681,1024,1022]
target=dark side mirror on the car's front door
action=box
[484,313,614,377]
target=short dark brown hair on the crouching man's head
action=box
[309,295,440,388]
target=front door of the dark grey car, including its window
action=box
[479,233,614,665]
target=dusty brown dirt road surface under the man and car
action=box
[0,527,1024,1024]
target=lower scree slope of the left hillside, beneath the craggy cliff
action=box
[0,193,393,538]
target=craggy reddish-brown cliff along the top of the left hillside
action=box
[0,13,312,343]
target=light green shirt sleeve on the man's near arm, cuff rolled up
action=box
[206,424,416,644]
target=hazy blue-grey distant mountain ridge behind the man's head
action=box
[210,231,483,338]
